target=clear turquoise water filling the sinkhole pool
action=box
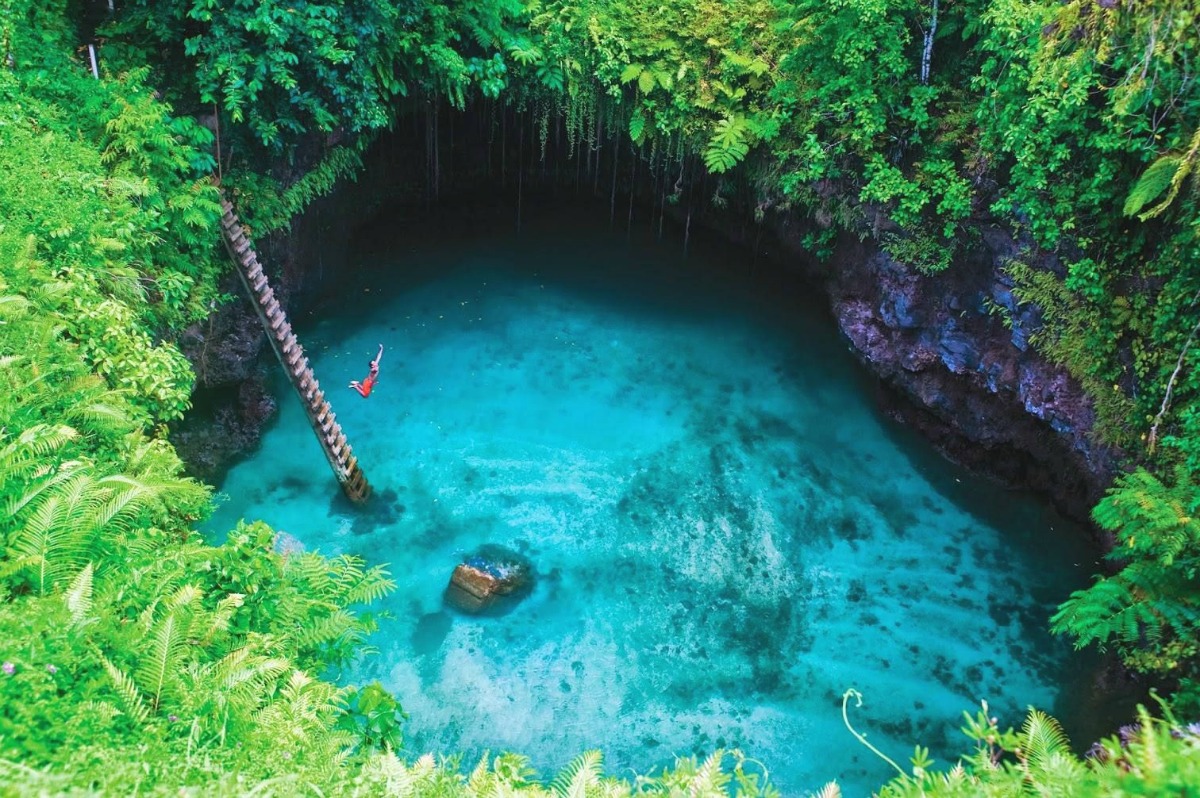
[210,204,1096,796]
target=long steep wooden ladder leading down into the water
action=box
[221,192,371,503]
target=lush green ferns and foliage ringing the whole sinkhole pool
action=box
[0,0,1200,796]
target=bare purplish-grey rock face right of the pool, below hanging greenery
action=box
[772,214,1120,521]
